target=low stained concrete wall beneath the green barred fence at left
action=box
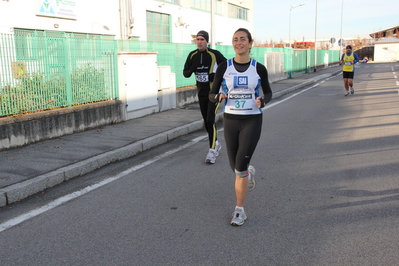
[0,101,122,150]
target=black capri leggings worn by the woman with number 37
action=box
[223,114,263,175]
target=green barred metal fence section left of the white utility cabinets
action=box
[0,30,118,116]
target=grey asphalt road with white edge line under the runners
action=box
[0,63,399,266]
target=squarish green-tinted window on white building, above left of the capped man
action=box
[147,11,170,42]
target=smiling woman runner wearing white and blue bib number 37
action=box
[209,28,272,225]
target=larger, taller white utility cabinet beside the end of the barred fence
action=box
[118,52,159,121]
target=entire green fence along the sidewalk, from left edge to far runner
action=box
[0,30,339,117]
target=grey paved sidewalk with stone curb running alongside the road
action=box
[0,66,341,207]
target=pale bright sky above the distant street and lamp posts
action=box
[252,0,399,43]
